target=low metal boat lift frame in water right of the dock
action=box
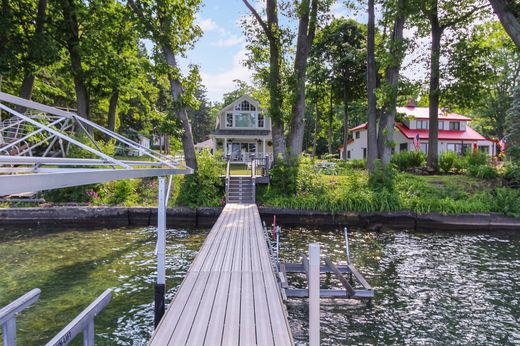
[263,223,374,302]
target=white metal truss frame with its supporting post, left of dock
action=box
[0,92,193,339]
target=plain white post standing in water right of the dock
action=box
[309,243,320,346]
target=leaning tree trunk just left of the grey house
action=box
[162,42,197,170]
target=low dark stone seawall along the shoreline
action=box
[0,207,520,231]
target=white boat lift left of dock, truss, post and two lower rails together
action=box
[0,92,193,346]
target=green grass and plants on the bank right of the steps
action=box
[257,170,520,217]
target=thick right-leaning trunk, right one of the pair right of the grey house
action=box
[288,0,318,157]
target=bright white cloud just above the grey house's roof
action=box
[201,48,252,101]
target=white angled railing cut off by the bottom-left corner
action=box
[0,288,41,346]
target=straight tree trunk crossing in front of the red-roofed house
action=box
[428,0,442,171]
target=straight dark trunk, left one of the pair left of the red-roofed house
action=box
[367,0,377,172]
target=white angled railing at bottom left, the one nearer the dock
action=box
[46,288,112,346]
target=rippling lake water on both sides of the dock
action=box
[0,224,520,345]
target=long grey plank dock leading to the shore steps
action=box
[149,204,294,346]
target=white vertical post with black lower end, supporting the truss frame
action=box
[155,177,166,327]
